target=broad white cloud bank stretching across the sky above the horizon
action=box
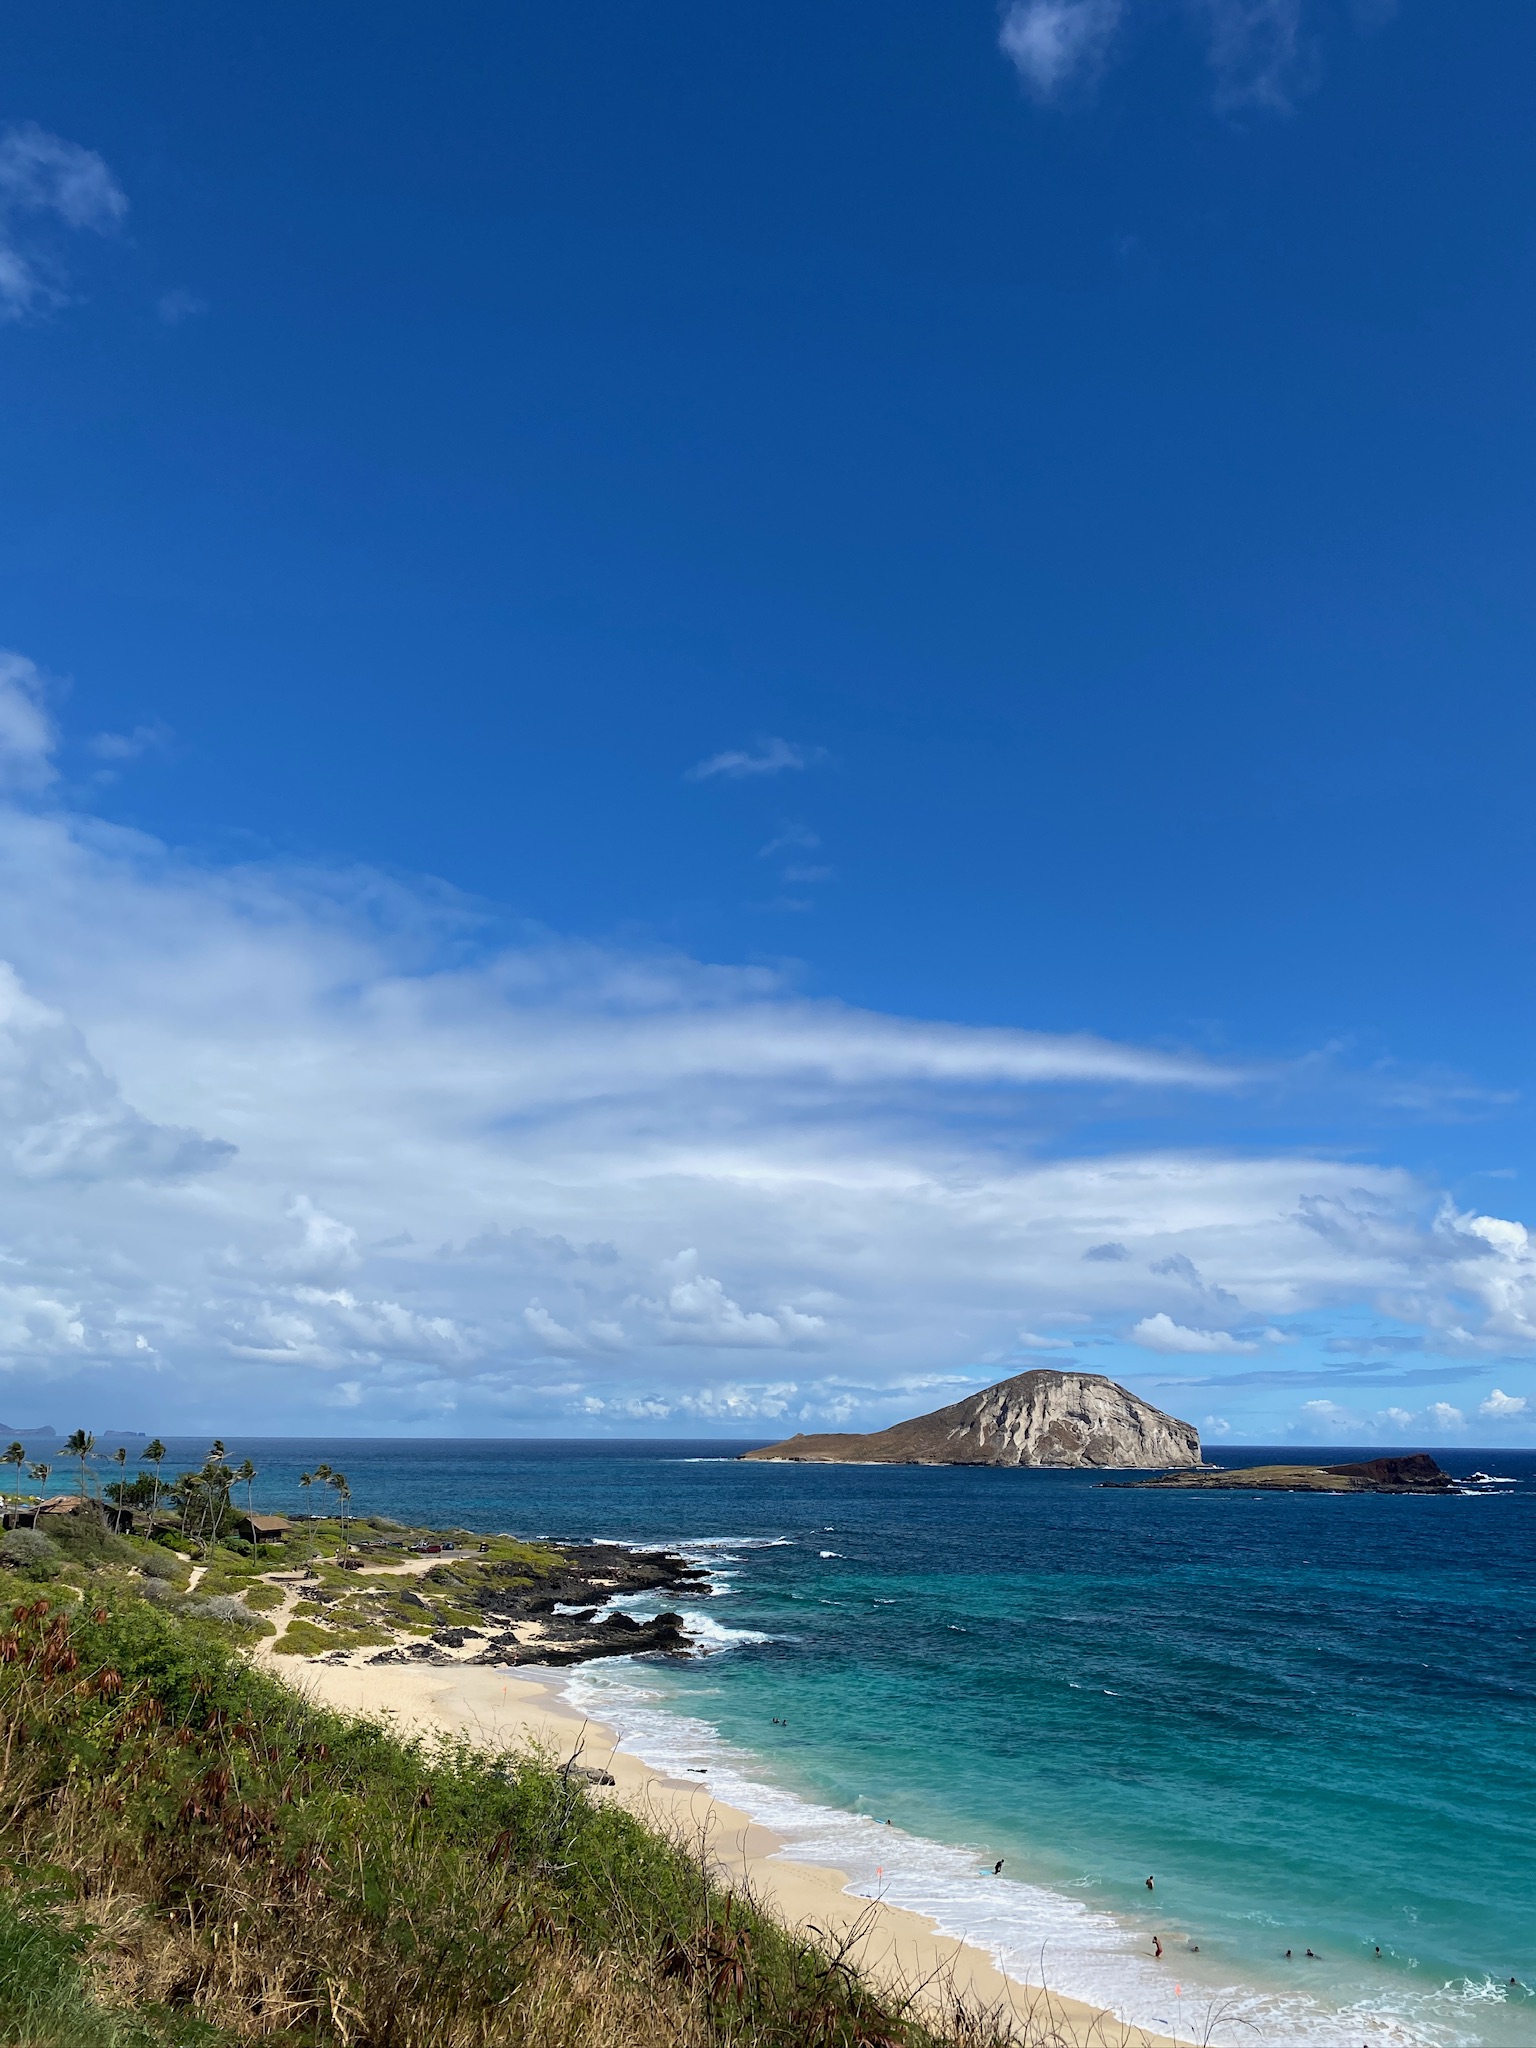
[0,657,1536,1438]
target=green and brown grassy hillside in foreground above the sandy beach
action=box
[0,1563,1015,2048]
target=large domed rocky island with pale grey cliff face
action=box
[743,1370,1200,1473]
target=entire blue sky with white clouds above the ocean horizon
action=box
[0,0,1536,1450]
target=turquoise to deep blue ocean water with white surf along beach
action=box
[123,1440,1536,2048]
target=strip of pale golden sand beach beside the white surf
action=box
[258,1651,1188,2048]
